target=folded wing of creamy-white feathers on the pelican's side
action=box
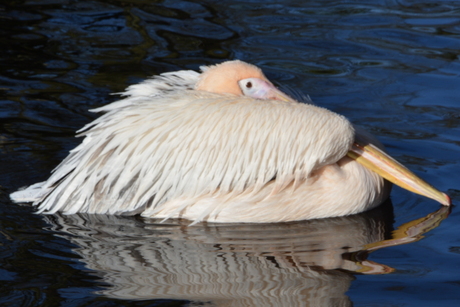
[30,90,354,215]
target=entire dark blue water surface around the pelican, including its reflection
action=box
[0,0,460,306]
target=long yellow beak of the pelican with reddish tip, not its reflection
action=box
[348,142,452,206]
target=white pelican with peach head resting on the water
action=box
[11,61,450,223]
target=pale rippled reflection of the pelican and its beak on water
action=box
[47,205,449,306]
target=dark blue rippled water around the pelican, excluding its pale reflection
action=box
[0,0,460,306]
